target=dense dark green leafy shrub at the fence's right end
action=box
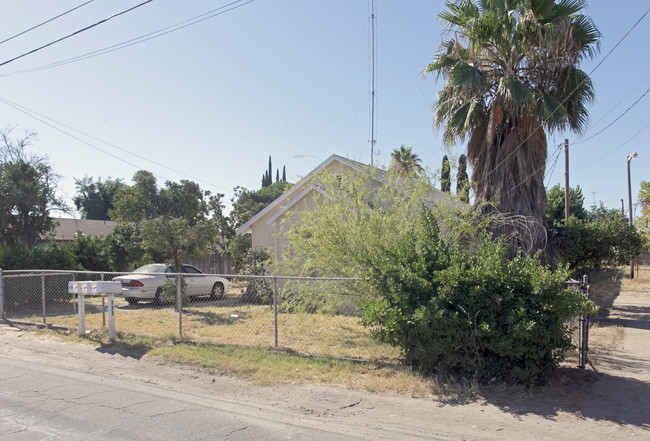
[363,213,590,385]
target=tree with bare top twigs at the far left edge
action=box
[0,129,64,246]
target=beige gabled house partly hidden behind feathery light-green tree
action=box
[236,155,458,260]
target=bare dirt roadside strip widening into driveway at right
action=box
[0,268,650,440]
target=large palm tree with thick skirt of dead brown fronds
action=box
[424,0,600,252]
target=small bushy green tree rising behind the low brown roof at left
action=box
[74,175,126,220]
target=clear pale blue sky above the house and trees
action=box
[0,0,650,216]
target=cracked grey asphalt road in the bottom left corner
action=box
[0,356,360,441]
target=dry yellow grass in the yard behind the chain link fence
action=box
[40,298,399,360]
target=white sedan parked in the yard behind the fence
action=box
[113,263,230,305]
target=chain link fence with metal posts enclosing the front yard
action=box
[0,270,399,360]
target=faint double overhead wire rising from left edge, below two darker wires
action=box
[0,0,255,77]
